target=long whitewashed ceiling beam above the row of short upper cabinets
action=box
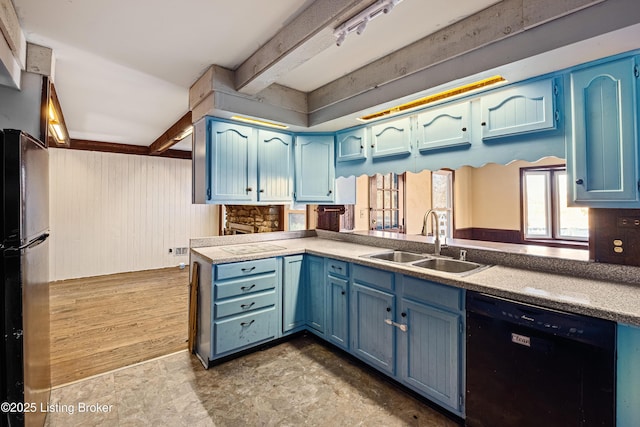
[308,0,604,117]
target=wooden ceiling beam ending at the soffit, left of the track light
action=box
[235,0,374,95]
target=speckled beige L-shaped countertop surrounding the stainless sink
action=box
[191,230,640,326]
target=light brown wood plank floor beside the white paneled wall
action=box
[50,267,189,386]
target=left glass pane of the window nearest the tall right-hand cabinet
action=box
[524,172,551,237]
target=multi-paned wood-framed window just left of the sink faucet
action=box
[369,173,404,233]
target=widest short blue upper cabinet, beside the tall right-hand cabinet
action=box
[480,79,557,140]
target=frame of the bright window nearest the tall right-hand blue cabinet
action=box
[520,165,589,249]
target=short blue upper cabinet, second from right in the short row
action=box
[417,101,471,151]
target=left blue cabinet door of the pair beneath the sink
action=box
[350,281,396,376]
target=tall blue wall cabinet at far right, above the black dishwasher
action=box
[567,58,640,208]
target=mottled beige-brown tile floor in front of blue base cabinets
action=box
[46,336,458,427]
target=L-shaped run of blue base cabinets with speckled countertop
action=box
[191,230,640,425]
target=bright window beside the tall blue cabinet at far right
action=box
[520,166,589,241]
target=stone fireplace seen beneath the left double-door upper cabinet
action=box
[224,205,284,234]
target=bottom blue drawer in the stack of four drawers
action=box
[214,307,278,355]
